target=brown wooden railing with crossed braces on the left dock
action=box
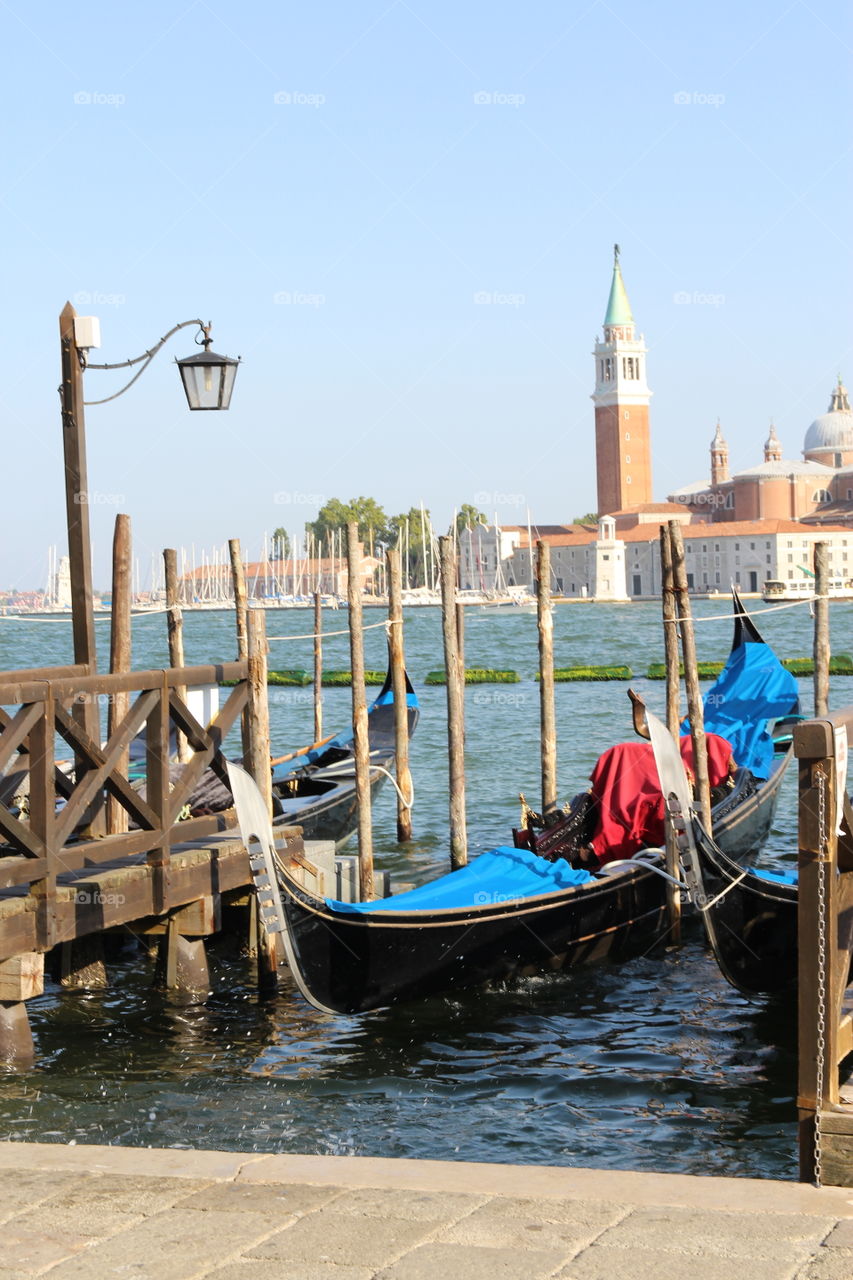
[0,653,257,951]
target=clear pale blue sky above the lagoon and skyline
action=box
[0,0,853,588]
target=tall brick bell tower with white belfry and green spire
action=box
[592,244,652,517]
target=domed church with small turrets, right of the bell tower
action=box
[669,378,853,524]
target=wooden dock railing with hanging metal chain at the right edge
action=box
[794,707,853,1185]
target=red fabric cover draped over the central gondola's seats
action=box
[590,733,734,863]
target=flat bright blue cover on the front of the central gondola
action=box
[325,845,593,915]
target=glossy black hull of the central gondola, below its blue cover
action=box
[280,869,669,1014]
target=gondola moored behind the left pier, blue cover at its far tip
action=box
[273,672,420,845]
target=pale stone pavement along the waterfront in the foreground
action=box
[0,1143,853,1280]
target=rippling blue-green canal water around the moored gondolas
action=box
[0,596,853,1177]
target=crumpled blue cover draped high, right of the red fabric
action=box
[703,640,799,778]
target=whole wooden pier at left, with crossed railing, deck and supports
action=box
[0,645,302,1065]
